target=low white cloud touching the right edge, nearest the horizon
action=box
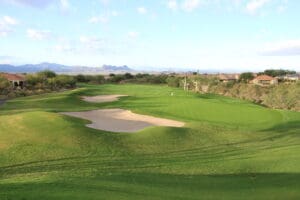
[260,40,300,56]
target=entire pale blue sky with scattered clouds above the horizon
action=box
[0,0,300,71]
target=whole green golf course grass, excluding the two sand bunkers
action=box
[0,84,300,200]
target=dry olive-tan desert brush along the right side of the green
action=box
[182,73,300,111]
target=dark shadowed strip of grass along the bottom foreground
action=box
[0,172,300,200]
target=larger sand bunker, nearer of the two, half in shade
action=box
[62,109,184,132]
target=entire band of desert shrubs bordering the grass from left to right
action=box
[0,70,300,111]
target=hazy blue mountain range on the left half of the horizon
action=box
[0,62,134,74]
